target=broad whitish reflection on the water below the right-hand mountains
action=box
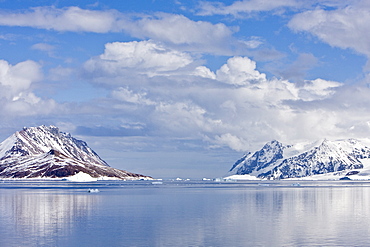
[215,184,370,246]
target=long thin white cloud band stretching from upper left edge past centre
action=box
[0,6,236,54]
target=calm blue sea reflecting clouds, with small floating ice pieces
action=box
[0,180,370,247]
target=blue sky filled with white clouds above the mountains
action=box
[0,0,370,178]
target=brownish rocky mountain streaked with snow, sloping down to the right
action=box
[0,126,150,179]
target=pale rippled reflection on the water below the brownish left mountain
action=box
[0,185,101,246]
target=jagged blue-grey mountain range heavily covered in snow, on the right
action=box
[229,139,370,179]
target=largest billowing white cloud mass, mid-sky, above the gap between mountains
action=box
[79,41,349,151]
